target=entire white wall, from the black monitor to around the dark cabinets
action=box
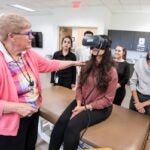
[28,7,150,59]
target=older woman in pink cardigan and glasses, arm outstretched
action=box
[0,14,83,150]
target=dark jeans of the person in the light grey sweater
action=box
[129,91,150,115]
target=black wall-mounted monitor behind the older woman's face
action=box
[32,31,43,48]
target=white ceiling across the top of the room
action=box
[0,0,150,14]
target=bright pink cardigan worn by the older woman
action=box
[0,50,60,136]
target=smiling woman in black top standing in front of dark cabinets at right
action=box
[113,45,130,105]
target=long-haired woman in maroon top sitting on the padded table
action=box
[49,36,118,150]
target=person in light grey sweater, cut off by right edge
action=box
[129,50,150,115]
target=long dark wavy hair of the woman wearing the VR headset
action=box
[79,35,114,91]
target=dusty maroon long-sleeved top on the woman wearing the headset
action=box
[76,67,118,109]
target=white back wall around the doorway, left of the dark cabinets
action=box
[28,7,111,55]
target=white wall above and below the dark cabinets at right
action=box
[109,13,150,59]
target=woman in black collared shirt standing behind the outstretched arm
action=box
[51,36,76,89]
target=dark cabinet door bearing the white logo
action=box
[133,32,149,52]
